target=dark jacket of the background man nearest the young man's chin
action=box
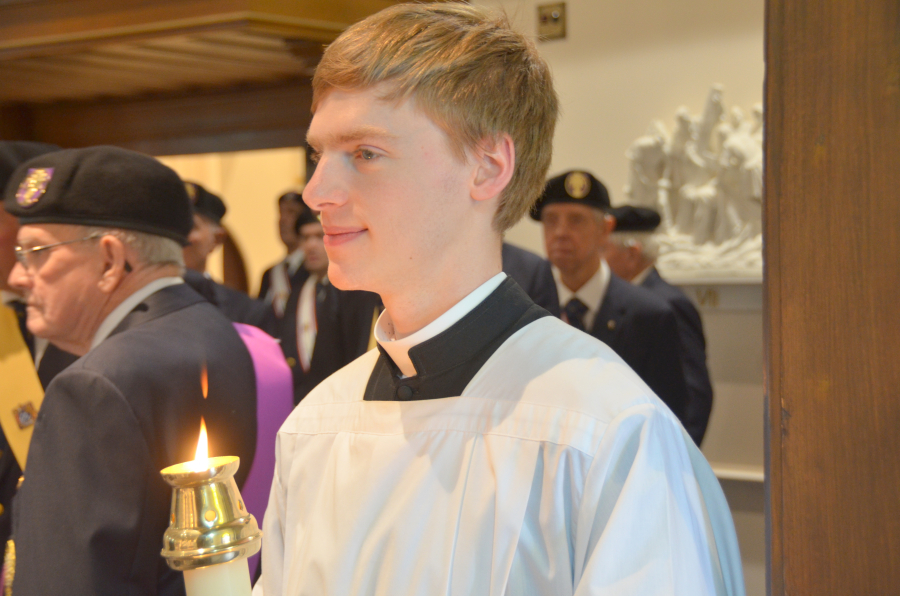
[279,274,381,404]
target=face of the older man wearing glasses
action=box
[9,224,103,344]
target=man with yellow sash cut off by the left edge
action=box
[0,141,77,544]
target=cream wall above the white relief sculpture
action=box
[473,0,764,254]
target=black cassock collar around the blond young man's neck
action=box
[363,277,550,401]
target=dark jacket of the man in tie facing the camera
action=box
[590,273,688,422]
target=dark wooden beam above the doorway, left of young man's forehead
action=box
[15,79,312,155]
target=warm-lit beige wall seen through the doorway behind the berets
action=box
[159,148,306,296]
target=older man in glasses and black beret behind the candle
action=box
[4,147,256,596]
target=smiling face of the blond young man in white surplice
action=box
[303,83,472,294]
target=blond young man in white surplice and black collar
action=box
[259,3,742,596]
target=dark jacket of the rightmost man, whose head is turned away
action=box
[641,267,713,446]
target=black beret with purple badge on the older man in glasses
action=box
[3,147,194,246]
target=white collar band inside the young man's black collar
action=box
[375,271,506,377]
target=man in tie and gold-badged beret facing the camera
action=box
[531,170,688,421]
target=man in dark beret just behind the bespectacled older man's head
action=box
[183,182,275,334]
